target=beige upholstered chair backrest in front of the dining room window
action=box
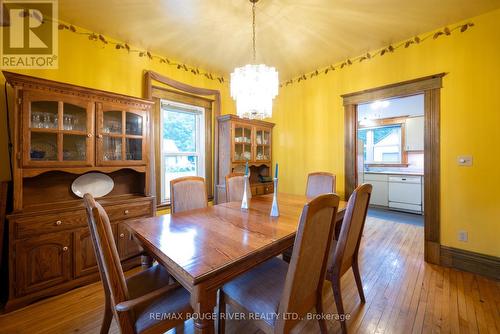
[170,176,208,213]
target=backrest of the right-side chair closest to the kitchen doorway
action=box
[328,184,372,276]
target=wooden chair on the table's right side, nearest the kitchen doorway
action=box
[326,184,372,333]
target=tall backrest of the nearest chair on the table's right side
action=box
[275,193,339,333]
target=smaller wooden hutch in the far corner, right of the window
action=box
[216,115,274,203]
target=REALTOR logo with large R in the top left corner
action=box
[0,0,58,69]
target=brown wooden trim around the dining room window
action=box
[144,71,221,206]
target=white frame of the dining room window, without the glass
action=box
[159,99,206,202]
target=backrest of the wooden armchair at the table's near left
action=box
[83,194,134,331]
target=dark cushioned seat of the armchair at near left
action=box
[127,265,192,333]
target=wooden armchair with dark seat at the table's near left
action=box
[83,194,192,334]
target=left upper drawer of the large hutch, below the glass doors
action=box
[14,210,87,239]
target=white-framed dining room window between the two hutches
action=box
[160,100,205,203]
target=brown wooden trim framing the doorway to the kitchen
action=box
[342,73,445,264]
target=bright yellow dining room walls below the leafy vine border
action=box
[0,10,500,256]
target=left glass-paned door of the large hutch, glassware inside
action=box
[23,91,94,167]
